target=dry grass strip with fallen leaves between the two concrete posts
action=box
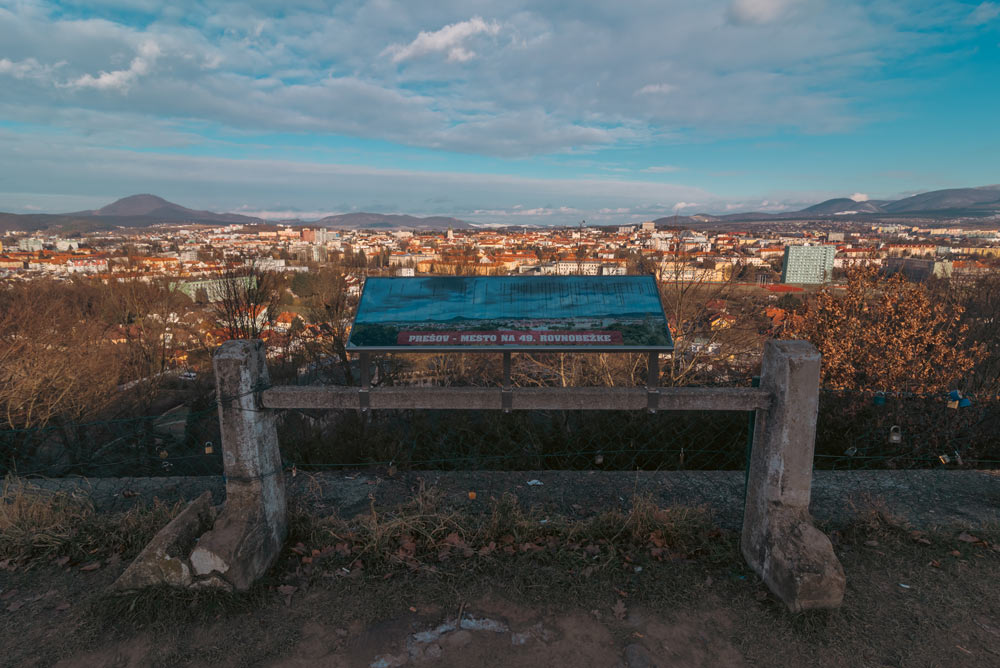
[288,488,738,576]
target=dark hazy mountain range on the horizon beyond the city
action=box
[0,185,1000,233]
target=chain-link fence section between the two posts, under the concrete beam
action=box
[279,410,750,471]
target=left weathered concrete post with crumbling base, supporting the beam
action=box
[191,340,288,590]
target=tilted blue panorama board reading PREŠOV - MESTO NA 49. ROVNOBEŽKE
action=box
[348,276,673,349]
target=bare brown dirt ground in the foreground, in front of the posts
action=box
[0,526,1000,668]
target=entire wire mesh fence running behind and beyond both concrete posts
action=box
[0,390,1000,488]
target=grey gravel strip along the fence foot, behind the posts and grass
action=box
[17,470,1000,528]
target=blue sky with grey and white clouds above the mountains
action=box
[0,0,1000,224]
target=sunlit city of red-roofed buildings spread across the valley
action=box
[0,196,1000,382]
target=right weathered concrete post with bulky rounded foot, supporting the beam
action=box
[741,341,845,612]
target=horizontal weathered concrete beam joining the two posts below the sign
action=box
[261,385,771,411]
